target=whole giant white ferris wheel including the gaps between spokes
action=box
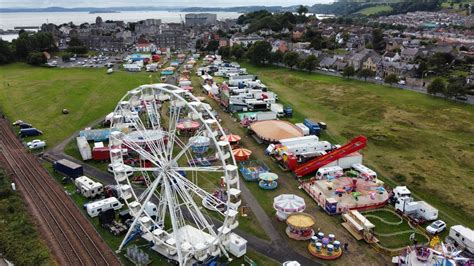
[109,84,241,265]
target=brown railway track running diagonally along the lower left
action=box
[0,119,120,265]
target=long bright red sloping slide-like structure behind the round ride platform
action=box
[293,136,367,177]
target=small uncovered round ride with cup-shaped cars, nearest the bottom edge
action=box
[308,232,342,260]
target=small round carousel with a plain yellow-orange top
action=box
[286,212,315,240]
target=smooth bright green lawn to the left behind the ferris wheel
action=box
[0,64,154,147]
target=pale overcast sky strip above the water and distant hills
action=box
[0,0,334,8]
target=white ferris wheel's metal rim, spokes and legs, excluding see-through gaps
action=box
[109,83,240,265]
